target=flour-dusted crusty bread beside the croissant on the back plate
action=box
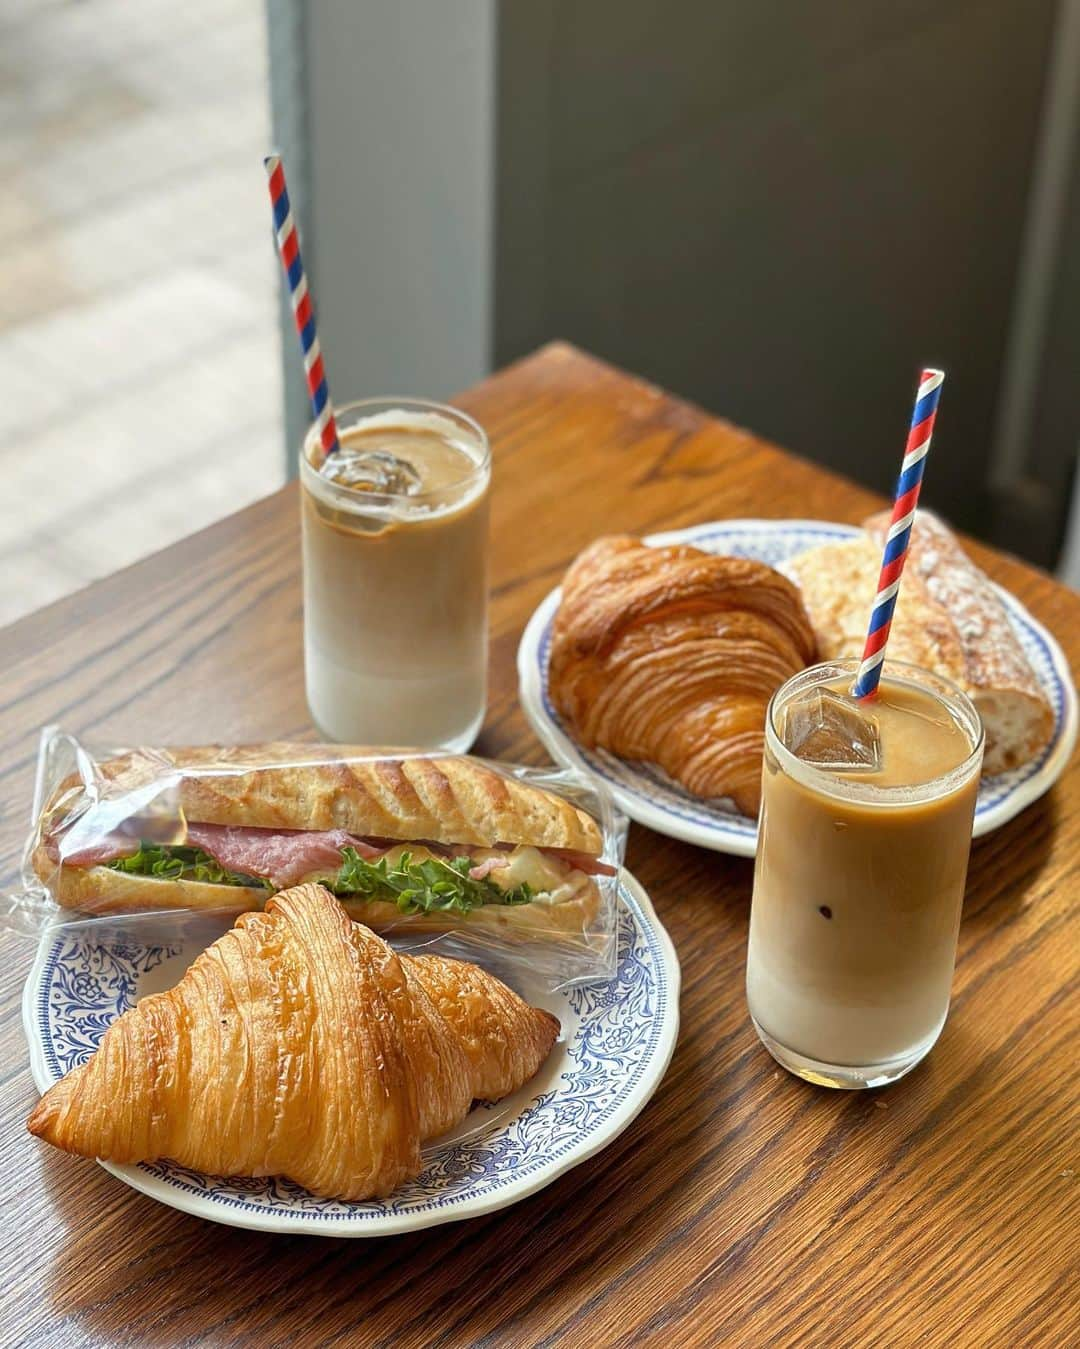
[785,511,1054,773]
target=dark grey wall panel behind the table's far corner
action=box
[495,0,1076,547]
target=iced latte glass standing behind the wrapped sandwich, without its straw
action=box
[299,398,491,753]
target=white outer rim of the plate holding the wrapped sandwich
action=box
[22,867,681,1237]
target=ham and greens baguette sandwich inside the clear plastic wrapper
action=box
[31,745,615,935]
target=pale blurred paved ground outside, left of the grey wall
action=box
[0,0,280,622]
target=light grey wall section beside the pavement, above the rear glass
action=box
[296,0,495,437]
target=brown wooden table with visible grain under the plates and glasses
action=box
[0,345,1080,1349]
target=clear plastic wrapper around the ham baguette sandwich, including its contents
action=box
[0,727,626,990]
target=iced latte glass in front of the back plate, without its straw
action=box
[747,661,983,1087]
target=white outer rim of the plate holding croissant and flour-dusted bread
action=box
[518,518,1080,857]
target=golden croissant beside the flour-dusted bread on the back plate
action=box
[549,536,814,815]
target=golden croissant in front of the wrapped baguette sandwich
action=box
[28,885,560,1201]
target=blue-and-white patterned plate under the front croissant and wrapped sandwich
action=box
[23,871,680,1237]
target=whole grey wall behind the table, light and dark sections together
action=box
[268,0,1080,564]
